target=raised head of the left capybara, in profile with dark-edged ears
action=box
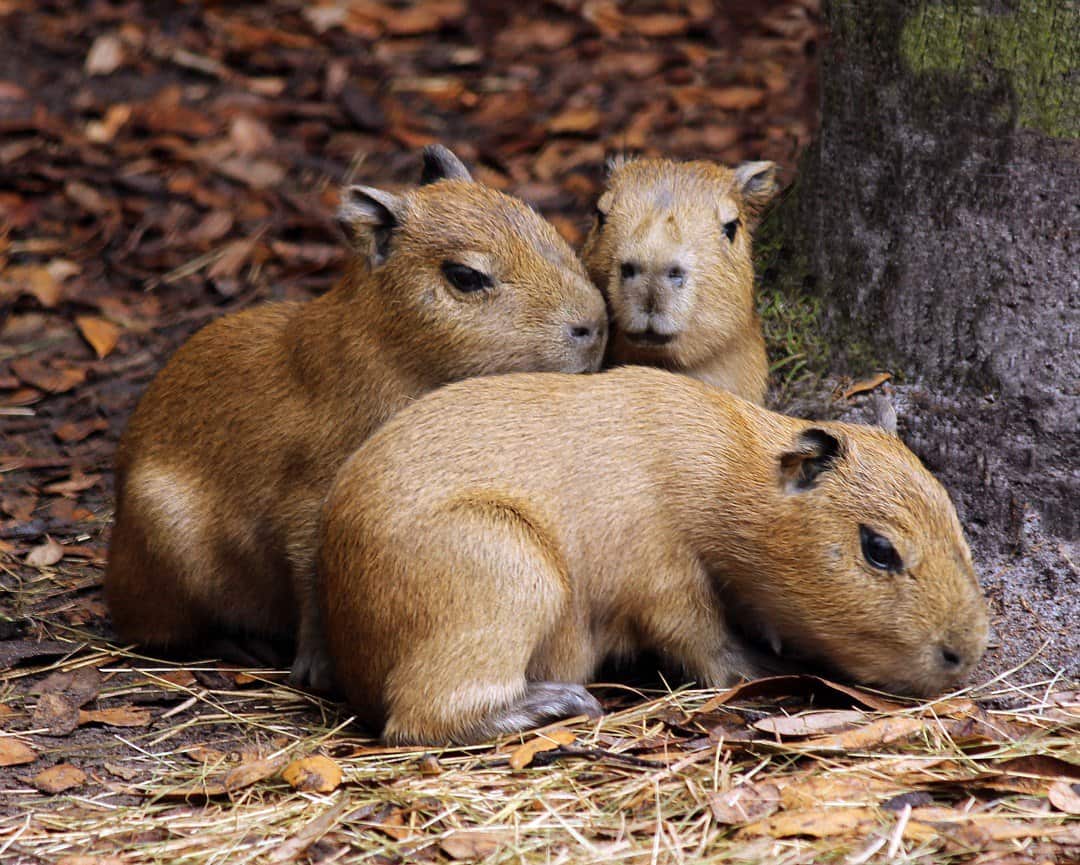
[339,145,607,381]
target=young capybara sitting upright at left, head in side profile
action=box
[105,148,606,687]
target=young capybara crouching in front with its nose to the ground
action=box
[320,366,987,743]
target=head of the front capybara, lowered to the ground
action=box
[760,423,988,695]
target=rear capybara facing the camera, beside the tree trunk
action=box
[582,159,775,404]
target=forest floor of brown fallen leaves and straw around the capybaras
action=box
[0,0,1080,865]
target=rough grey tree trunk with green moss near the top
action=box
[785,0,1080,678]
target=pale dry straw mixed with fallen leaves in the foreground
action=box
[0,632,1080,865]
